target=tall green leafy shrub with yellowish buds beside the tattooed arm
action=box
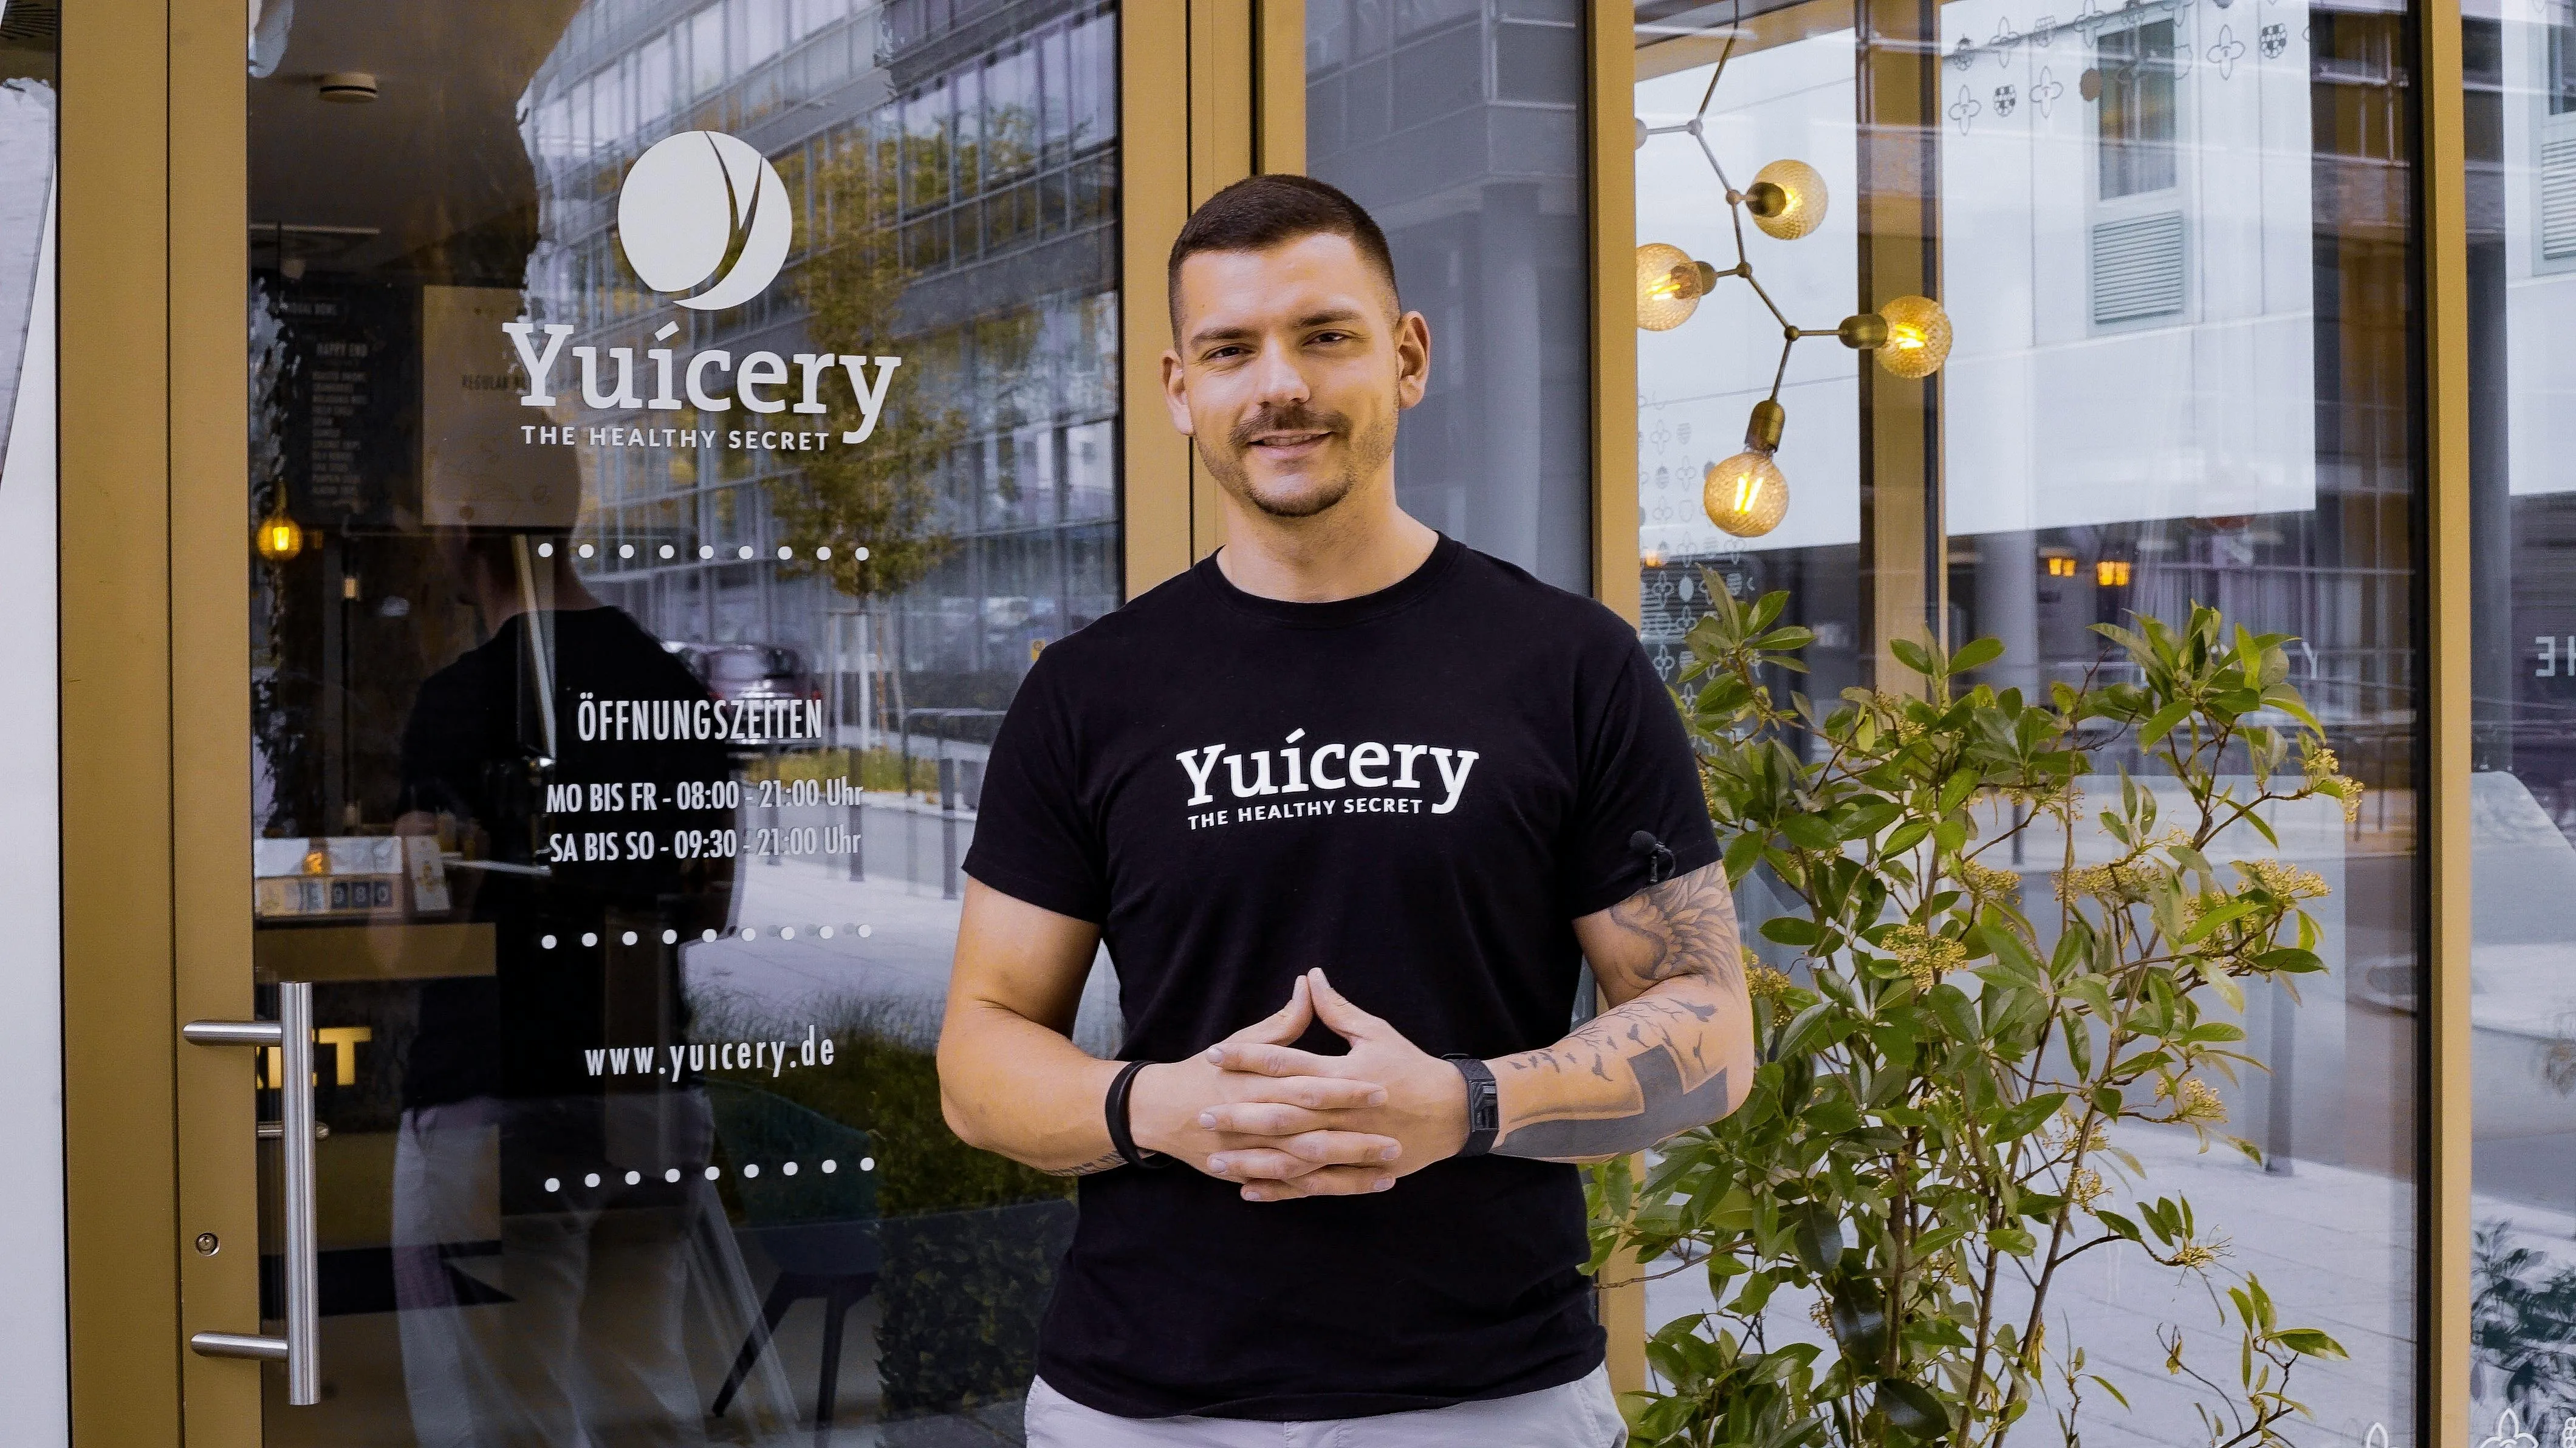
[1589,582,2360,1448]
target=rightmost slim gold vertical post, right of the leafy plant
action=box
[2416,0,2476,1446]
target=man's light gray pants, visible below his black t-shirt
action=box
[1028,1368,1628,1448]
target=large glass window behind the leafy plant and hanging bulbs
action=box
[1636,0,2411,1446]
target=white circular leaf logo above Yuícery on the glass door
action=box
[618,131,796,312]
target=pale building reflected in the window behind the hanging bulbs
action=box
[1639,0,2416,784]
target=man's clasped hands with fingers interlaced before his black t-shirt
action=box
[1128,969,1466,1201]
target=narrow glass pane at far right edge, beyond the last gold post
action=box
[2445,2,2576,1440]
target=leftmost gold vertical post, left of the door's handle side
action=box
[57,0,184,1443]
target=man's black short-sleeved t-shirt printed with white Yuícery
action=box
[966,539,1716,1419]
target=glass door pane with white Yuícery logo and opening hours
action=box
[242,0,1120,1448]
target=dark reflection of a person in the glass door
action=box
[394,536,762,1448]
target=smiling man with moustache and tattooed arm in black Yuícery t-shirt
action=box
[940,178,1754,1448]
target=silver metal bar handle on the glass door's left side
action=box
[180,982,322,1407]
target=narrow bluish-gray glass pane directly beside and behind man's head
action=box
[1306,0,1592,593]
